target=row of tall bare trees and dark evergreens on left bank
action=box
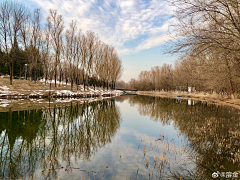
[0,1,123,90]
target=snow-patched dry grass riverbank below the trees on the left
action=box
[0,77,121,99]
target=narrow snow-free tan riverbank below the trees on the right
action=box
[137,91,240,109]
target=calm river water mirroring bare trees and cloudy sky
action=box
[0,96,240,180]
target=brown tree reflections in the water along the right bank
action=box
[129,96,240,179]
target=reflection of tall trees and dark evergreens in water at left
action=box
[0,100,120,179]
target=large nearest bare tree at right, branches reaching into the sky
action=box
[170,0,240,98]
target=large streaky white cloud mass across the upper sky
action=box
[30,0,173,55]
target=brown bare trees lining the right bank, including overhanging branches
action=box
[131,0,240,98]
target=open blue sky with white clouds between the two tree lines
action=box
[7,0,176,82]
